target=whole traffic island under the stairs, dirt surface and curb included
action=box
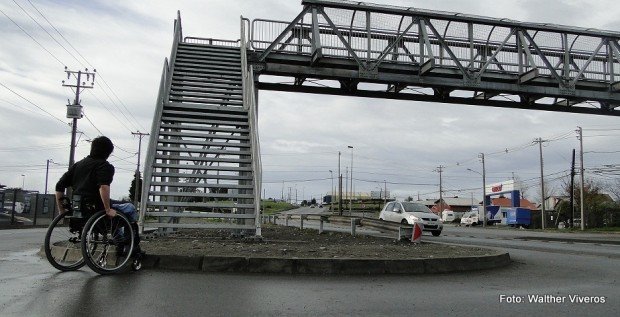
[142,225,511,274]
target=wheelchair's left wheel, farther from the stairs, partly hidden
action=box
[43,212,84,271]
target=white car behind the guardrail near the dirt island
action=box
[379,201,443,236]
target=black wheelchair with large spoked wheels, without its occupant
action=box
[44,197,143,275]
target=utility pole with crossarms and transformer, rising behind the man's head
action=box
[62,67,97,167]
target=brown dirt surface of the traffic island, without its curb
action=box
[142,224,496,259]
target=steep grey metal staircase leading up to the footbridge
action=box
[140,15,261,235]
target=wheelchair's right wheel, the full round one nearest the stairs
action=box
[81,211,134,274]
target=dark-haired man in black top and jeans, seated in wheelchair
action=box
[56,136,143,256]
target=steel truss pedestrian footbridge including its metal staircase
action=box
[141,0,620,235]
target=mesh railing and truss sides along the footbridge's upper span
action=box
[251,0,620,88]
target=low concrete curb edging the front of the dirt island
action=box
[142,252,511,275]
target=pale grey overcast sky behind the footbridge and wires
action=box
[0,0,620,200]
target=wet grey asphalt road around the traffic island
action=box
[0,227,620,316]
